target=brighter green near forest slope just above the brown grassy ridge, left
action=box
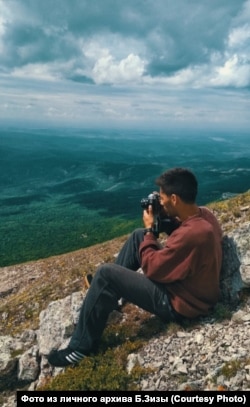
[0,203,141,266]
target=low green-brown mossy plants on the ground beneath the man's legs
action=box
[39,304,172,391]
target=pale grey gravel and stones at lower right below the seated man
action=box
[129,297,250,391]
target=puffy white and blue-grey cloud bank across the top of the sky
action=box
[0,0,250,83]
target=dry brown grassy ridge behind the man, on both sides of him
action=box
[0,191,250,335]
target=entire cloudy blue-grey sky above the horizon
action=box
[0,0,250,131]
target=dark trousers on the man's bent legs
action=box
[69,229,175,355]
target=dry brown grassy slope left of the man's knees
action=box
[0,237,126,335]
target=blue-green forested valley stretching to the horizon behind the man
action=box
[0,129,249,267]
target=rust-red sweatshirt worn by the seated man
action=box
[140,207,222,318]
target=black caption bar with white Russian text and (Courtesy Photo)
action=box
[17,391,250,407]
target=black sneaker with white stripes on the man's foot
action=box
[47,347,85,367]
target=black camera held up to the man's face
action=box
[141,192,180,237]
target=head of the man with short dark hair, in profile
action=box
[155,168,198,217]
